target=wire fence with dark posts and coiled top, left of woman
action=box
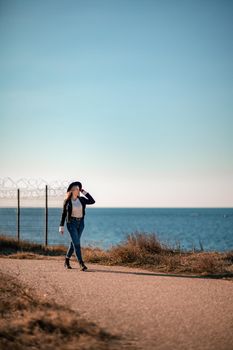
[0,177,72,245]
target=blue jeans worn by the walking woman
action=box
[66,217,84,263]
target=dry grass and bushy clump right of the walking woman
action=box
[84,231,233,277]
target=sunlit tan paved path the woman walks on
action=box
[0,258,233,350]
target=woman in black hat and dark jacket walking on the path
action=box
[59,181,95,271]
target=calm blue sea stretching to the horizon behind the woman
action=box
[0,206,233,252]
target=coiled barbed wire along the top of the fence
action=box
[0,177,71,199]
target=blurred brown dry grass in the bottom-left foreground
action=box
[0,273,133,350]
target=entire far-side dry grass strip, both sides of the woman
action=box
[0,231,233,278]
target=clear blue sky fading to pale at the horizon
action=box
[0,0,233,207]
